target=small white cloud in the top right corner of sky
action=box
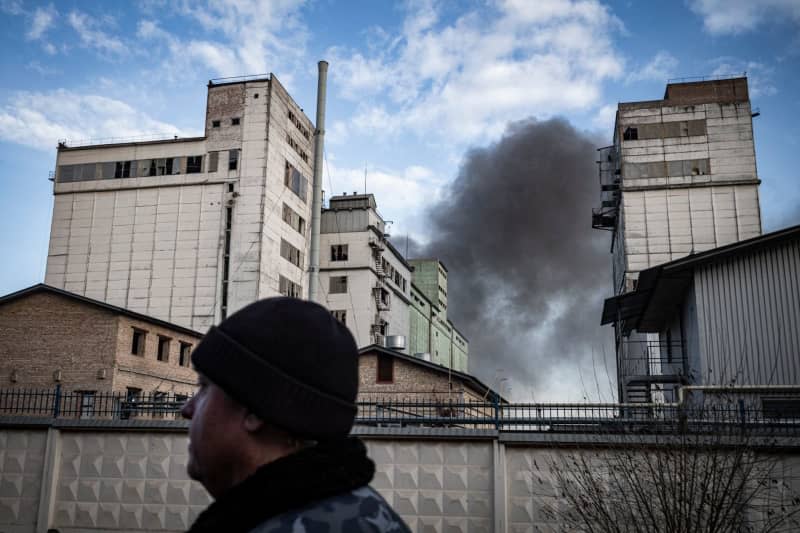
[690,0,800,35]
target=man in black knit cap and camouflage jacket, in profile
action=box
[182,298,409,533]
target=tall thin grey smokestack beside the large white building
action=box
[308,61,328,302]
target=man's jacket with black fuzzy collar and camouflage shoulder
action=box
[189,437,410,533]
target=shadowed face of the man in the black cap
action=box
[181,374,247,498]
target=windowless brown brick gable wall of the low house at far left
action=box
[0,293,117,391]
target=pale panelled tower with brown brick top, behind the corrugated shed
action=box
[592,78,761,402]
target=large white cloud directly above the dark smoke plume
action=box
[328,0,623,142]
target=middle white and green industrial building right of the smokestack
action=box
[319,193,469,372]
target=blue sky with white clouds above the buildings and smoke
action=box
[0,0,800,400]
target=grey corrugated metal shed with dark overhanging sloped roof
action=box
[603,226,800,404]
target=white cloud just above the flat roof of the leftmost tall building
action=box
[0,89,193,151]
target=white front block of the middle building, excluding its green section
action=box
[319,194,412,350]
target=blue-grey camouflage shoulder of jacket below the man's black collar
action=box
[250,486,410,533]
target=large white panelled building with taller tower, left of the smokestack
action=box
[45,75,314,331]
